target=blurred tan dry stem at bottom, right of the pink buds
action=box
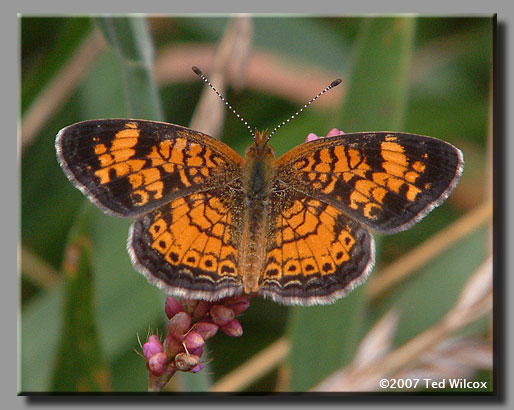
[211,337,290,392]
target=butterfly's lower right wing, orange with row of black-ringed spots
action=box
[259,186,375,305]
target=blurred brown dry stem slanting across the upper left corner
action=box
[21,30,106,149]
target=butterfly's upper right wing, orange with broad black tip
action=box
[277,132,464,233]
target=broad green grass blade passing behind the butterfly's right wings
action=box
[288,18,415,391]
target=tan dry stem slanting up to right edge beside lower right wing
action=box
[366,202,493,299]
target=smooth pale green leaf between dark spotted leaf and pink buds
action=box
[92,209,165,358]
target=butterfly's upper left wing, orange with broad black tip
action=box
[55,119,242,217]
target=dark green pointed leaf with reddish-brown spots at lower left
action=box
[51,205,110,392]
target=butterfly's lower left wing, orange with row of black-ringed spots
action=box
[129,188,242,300]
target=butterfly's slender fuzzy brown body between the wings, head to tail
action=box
[239,131,275,293]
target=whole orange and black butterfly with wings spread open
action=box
[56,77,464,305]
